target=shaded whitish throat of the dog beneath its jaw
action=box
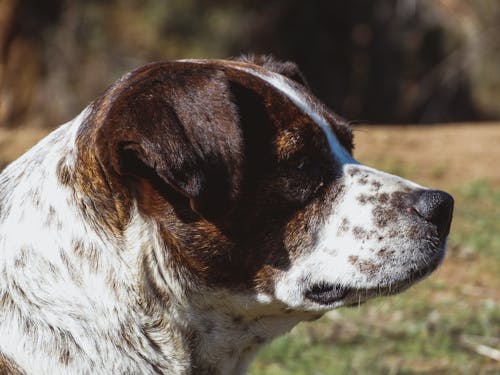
[130,214,312,375]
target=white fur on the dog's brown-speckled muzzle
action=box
[276,165,425,310]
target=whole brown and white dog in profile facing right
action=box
[0,58,453,375]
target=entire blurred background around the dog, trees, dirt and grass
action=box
[0,0,500,375]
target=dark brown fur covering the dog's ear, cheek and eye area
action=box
[57,62,352,300]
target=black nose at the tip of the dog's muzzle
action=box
[413,190,453,238]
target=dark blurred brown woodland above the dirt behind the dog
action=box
[0,0,500,127]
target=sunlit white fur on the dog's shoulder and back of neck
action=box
[0,111,180,374]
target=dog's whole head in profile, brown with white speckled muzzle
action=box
[77,60,453,314]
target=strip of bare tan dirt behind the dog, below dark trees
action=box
[0,123,500,188]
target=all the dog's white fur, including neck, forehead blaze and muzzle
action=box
[0,61,446,375]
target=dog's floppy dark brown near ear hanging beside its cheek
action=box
[97,64,244,220]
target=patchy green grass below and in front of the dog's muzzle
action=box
[250,178,500,375]
